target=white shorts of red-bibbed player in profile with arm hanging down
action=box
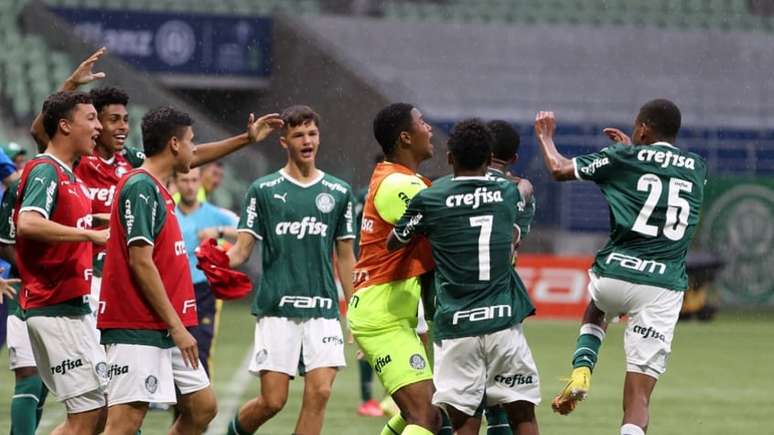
[107,344,210,406]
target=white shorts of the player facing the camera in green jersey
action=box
[249,317,347,376]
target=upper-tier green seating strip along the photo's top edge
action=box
[27,0,774,32]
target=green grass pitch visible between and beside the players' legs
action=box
[0,303,774,435]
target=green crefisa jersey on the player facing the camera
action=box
[238,170,355,319]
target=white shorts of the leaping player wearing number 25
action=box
[589,272,683,379]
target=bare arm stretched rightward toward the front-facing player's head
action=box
[191,113,283,168]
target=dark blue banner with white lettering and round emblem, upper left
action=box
[52,8,272,78]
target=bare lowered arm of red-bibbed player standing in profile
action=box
[129,244,199,368]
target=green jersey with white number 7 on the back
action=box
[393,176,534,340]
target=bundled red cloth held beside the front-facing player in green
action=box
[196,239,253,299]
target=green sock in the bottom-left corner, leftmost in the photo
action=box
[11,375,48,435]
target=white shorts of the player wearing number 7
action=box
[433,325,540,416]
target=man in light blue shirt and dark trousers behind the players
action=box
[174,168,238,376]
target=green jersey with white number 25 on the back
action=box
[573,142,707,291]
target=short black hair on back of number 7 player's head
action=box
[448,118,494,169]
